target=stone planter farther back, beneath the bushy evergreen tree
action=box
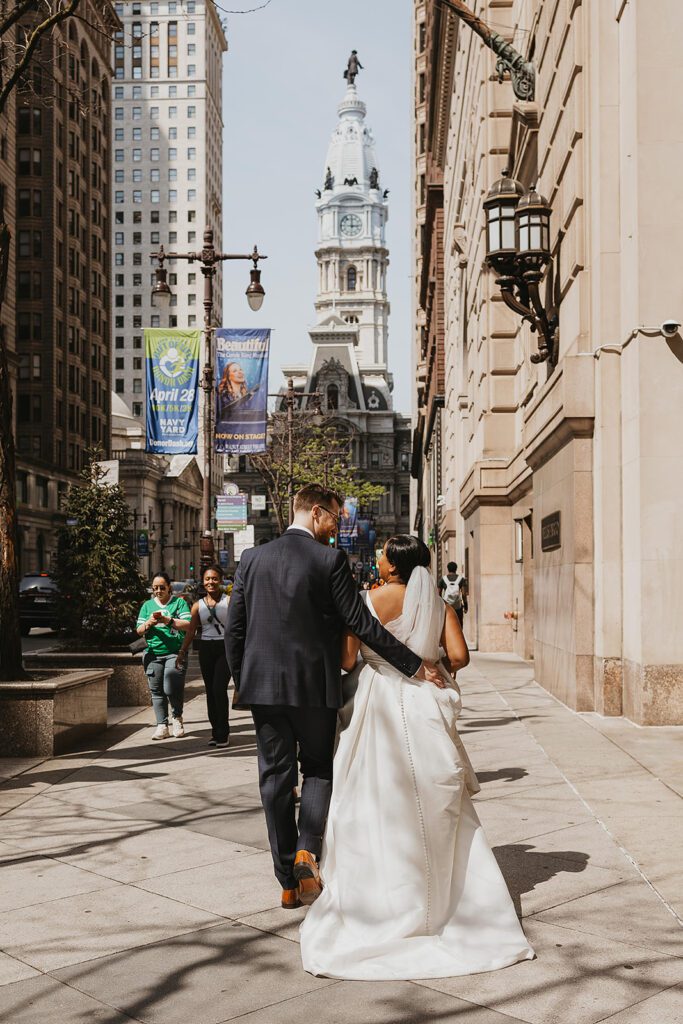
[24,649,152,708]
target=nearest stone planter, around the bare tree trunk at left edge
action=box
[0,669,111,758]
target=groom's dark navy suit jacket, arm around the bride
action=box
[225,529,421,708]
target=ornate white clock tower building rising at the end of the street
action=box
[232,66,411,571]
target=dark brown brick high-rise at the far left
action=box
[13,0,116,571]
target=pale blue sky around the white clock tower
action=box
[216,0,413,412]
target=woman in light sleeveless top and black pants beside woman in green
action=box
[175,565,230,746]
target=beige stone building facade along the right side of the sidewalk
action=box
[415,0,683,725]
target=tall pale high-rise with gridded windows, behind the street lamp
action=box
[112,0,227,421]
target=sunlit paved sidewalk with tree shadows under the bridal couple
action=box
[0,654,683,1024]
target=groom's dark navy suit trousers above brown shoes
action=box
[251,705,337,889]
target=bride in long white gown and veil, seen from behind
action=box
[301,536,533,981]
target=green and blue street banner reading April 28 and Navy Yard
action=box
[144,327,201,455]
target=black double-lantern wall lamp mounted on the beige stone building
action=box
[483,169,559,366]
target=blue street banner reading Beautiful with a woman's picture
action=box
[214,328,270,455]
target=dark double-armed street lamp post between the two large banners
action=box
[152,225,267,535]
